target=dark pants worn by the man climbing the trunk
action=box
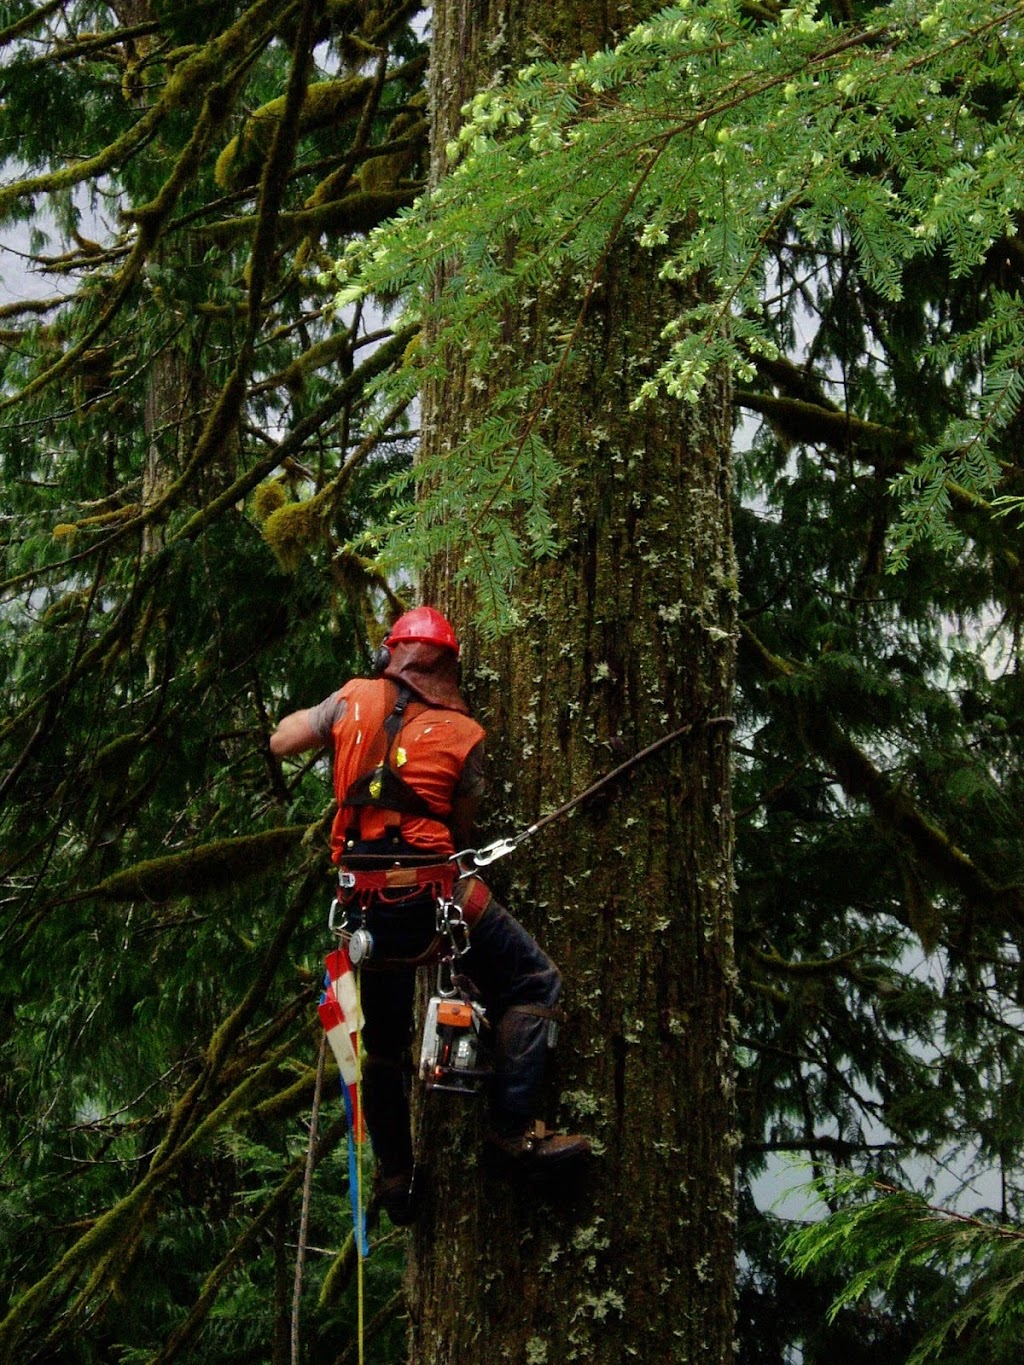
[348,879,561,1177]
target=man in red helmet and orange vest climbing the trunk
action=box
[270,606,590,1224]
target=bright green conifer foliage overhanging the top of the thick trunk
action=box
[329,0,1024,601]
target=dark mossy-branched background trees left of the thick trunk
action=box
[0,3,426,1361]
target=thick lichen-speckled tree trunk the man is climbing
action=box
[410,0,736,1365]
